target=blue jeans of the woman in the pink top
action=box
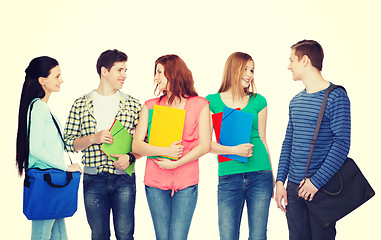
[146,185,198,240]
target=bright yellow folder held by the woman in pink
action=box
[148,105,185,159]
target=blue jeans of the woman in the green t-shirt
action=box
[218,171,273,240]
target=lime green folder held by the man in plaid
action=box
[101,119,135,176]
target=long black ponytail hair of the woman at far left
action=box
[16,56,58,176]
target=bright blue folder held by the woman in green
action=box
[219,107,254,163]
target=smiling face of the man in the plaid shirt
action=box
[102,62,127,89]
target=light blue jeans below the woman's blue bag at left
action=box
[32,218,67,240]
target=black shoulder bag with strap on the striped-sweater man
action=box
[305,84,375,227]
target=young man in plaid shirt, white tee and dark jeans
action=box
[64,50,141,240]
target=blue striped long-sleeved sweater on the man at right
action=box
[277,85,351,189]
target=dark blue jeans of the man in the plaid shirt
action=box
[83,173,136,240]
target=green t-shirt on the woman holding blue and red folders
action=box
[206,93,271,176]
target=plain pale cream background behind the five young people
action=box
[0,0,381,240]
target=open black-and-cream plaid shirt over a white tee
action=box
[64,91,141,173]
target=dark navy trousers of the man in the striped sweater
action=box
[286,182,336,240]
